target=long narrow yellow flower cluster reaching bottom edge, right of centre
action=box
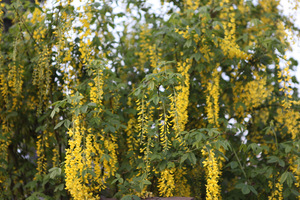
[201,149,221,200]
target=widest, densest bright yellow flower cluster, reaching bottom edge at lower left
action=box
[65,116,101,200]
